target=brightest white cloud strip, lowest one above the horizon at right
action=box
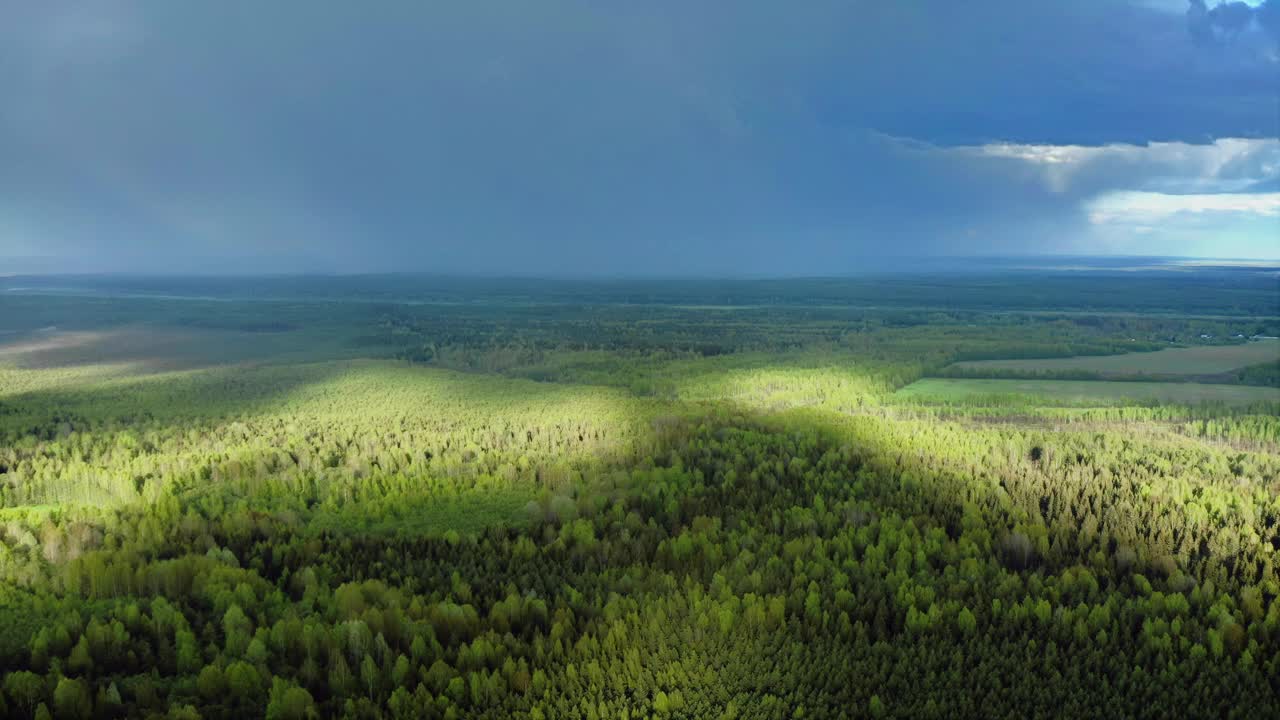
[1087,192,1280,227]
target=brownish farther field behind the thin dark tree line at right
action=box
[952,340,1280,375]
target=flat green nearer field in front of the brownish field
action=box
[893,378,1280,406]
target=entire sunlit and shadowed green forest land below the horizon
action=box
[0,268,1280,719]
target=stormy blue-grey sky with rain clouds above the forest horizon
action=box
[0,0,1280,275]
